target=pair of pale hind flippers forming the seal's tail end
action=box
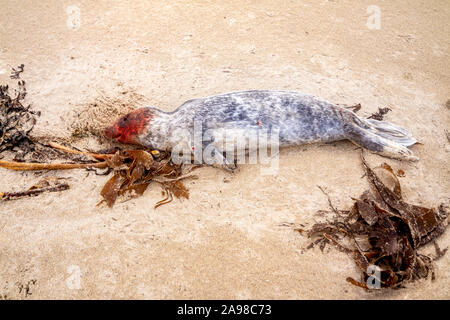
[345,113,419,161]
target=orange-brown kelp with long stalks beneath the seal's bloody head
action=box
[0,138,196,208]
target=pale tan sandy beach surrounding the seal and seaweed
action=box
[0,0,450,299]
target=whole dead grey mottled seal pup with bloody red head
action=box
[105,90,418,164]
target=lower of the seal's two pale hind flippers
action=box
[346,126,419,161]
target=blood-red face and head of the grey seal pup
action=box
[105,108,153,144]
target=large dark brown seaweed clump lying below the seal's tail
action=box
[300,158,448,289]
